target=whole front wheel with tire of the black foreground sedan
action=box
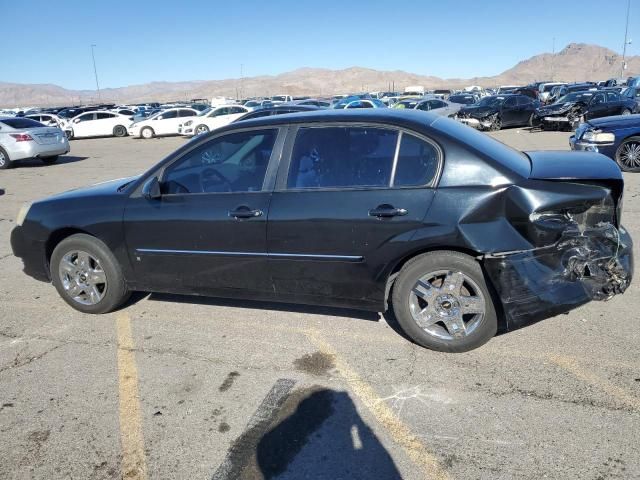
[50,234,130,313]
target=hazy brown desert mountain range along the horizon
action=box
[0,43,640,108]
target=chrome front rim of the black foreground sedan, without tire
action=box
[58,250,107,305]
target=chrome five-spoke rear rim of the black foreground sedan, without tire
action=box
[409,270,486,340]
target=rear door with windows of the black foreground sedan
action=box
[267,124,441,308]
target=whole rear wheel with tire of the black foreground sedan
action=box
[392,251,498,352]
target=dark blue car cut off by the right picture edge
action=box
[569,115,640,172]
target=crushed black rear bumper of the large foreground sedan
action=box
[484,222,633,329]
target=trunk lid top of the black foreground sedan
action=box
[525,151,622,180]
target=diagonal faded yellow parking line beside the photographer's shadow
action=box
[305,330,451,480]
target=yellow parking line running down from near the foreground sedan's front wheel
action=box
[116,313,147,480]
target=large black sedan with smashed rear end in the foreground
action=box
[11,109,633,352]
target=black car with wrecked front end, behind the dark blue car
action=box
[533,90,638,131]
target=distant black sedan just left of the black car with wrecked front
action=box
[456,94,540,130]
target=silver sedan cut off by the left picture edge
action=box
[0,117,70,169]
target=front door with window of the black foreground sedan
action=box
[124,128,278,296]
